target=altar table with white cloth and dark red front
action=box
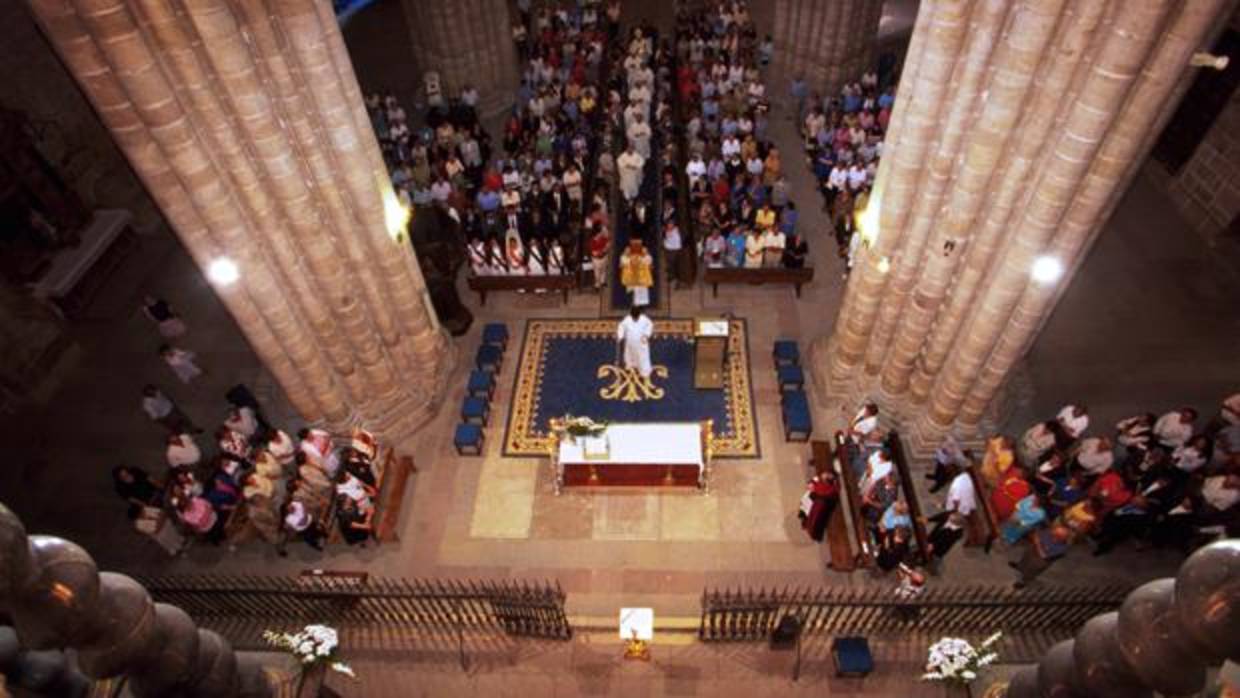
[551,420,712,495]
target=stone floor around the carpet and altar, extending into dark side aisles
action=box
[0,1,1240,696]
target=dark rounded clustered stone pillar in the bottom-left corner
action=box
[0,505,264,698]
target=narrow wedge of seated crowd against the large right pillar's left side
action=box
[792,72,895,275]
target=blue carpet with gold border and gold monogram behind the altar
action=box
[503,320,760,457]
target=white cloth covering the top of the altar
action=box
[559,422,702,469]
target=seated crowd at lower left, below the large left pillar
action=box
[121,386,378,554]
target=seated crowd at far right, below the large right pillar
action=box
[928,394,1240,586]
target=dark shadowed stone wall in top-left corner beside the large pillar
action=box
[0,0,167,233]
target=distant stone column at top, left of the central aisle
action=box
[404,0,520,115]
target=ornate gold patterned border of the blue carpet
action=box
[503,319,761,459]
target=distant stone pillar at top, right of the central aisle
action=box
[771,0,883,95]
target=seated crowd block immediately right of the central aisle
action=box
[676,0,808,276]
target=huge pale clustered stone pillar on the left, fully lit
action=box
[30,0,450,439]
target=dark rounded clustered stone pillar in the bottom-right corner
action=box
[1006,539,1240,698]
